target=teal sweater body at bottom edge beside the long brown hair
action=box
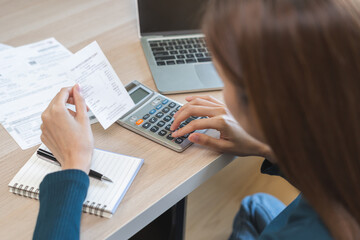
[259,195,333,240]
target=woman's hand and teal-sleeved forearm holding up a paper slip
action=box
[33,85,93,239]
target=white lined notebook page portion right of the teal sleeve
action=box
[85,149,143,213]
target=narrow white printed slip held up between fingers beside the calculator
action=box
[65,42,135,129]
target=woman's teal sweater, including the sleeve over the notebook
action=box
[33,160,332,240]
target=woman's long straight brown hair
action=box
[204,0,360,239]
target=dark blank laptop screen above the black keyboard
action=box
[137,0,209,35]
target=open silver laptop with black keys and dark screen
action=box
[135,0,223,94]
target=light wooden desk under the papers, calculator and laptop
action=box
[0,0,233,239]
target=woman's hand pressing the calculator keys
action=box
[171,96,271,158]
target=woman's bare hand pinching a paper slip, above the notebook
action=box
[41,85,94,173]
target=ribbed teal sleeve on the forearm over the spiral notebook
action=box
[33,169,89,239]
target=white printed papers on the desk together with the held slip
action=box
[0,38,134,149]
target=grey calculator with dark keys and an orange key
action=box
[117,80,206,152]
